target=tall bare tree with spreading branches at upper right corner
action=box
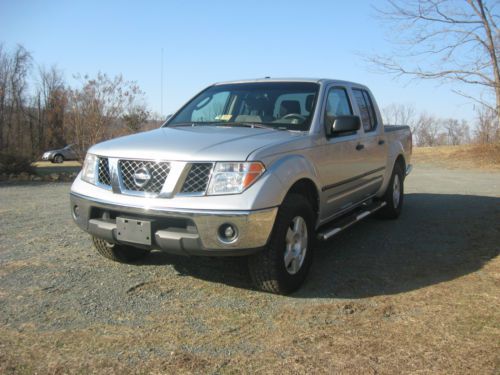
[369,0,500,117]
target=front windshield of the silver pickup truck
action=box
[166,82,318,131]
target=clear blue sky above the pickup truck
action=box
[0,0,484,120]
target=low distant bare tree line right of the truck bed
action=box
[382,104,500,146]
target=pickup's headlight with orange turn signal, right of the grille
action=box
[207,162,266,195]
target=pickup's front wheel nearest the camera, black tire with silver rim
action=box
[248,193,315,294]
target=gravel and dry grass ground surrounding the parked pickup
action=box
[0,164,500,374]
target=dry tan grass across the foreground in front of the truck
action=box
[0,258,500,374]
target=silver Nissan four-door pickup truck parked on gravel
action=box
[70,79,412,294]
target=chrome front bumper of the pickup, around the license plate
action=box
[70,192,278,256]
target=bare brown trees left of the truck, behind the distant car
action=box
[0,45,159,160]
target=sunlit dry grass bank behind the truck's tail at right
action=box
[413,144,500,170]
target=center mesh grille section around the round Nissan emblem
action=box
[119,160,170,194]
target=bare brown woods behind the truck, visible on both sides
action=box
[0,33,500,166]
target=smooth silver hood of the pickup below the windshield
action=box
[89,126,307,161]
